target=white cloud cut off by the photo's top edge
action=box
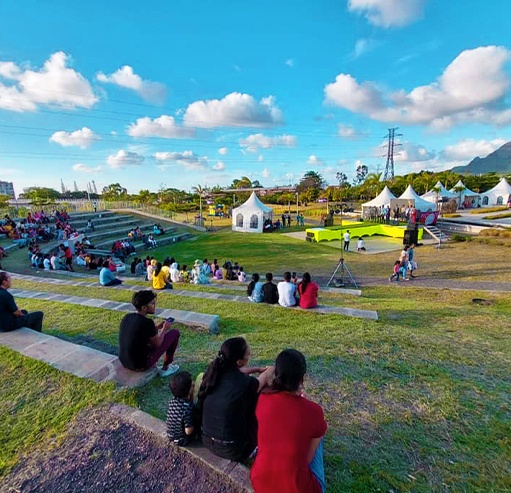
[348,0,426,28]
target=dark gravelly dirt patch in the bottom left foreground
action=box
[0,408,245,493]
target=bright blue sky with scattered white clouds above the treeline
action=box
[0,0,511,193]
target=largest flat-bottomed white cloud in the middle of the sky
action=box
[184,92,283,128]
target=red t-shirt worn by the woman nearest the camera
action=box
[250,392,327,493]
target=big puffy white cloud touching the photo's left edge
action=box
[0,51,98,112]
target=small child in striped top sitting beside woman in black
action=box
[167,371,195,445]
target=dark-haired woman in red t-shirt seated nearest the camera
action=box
[250,349,327,493]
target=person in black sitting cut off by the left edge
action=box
[0,272,44,332]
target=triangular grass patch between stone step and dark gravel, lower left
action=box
[0,347,134,476]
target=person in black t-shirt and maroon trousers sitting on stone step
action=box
[119,290,180,377]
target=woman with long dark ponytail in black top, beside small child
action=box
[198,337,273,461]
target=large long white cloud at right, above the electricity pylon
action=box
[325,46,511,130]
